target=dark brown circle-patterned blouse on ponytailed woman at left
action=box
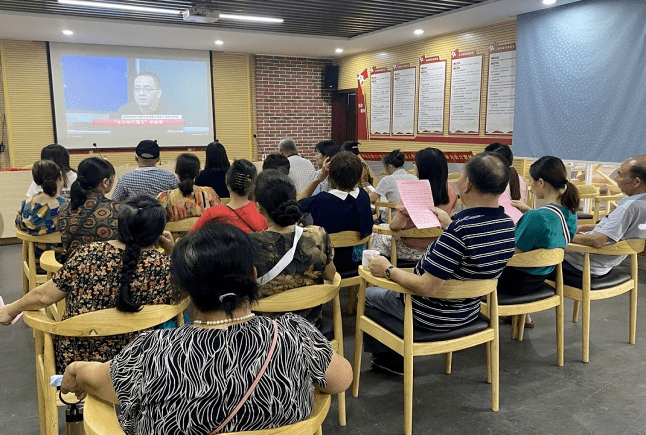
[57,192,119,256]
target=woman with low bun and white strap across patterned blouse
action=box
[249,170,336,326]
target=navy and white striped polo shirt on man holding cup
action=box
[413,207,515,331]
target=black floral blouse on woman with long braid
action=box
[52,242,179,373]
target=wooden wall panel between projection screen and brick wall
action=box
[211,52,256,160]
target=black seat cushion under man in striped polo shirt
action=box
[366,307,489,342]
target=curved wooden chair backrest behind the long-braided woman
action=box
[24,296,190,337]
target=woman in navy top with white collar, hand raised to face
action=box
[299,151,372,273]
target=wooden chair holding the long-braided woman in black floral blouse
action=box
[24,297,189,435]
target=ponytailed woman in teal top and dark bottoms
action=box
[498,156,579,327]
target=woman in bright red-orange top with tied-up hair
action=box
[191,159,267,233]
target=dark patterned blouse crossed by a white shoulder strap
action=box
[249,225,334,323]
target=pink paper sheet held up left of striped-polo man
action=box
[397,180,440,229]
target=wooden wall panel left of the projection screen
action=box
[0,40,54,167]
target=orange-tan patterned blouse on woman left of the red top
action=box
[157,186,222,221]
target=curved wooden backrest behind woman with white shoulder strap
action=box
[253,273,341,313]
